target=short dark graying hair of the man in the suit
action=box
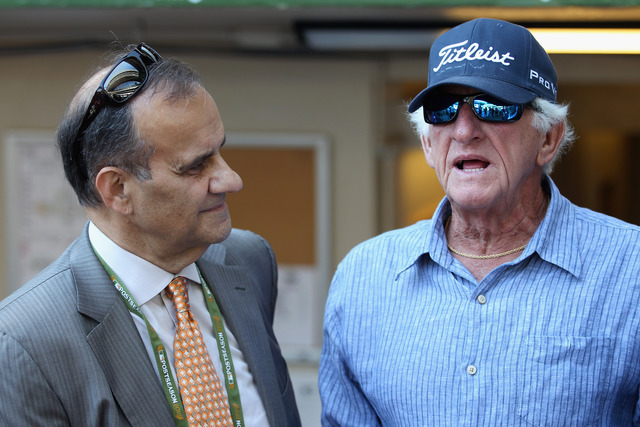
[56,46,204,207]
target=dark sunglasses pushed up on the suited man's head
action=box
[73,43,162,178]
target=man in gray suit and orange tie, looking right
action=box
[0,44,300,427]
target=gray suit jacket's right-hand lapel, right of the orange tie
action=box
[198,262,284,425]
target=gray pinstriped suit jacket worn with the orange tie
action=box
[0,228,300,427]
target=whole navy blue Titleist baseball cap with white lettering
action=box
[409,18,557,113]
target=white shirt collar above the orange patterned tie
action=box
[89,222,200,306]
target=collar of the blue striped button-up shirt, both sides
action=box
[396,176,582,278]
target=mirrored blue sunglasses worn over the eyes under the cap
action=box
[422,93,525,125]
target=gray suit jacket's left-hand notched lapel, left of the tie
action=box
[71,231,174,426]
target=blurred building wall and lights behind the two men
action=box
[0,0,640,426]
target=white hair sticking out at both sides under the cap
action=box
[408,98,576,175]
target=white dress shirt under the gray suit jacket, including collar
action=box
[89,223,269,427]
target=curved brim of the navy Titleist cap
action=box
[409,76,540,113]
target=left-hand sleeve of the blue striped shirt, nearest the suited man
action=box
[319,266,382,427]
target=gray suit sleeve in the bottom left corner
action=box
[0,331,70,427]
